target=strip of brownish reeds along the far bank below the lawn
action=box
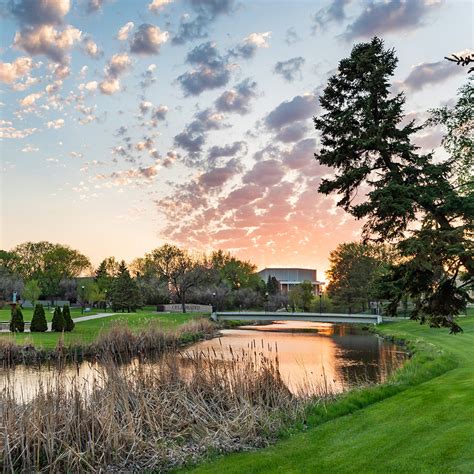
[0,318,219,366]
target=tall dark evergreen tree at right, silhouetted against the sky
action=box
[314,38,474,332]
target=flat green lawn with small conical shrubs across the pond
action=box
[0,309,207,349]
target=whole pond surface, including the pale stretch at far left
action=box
[0,321,407,400]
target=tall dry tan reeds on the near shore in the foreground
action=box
[0,342,329,472]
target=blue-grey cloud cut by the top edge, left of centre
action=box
[172,0,235,44]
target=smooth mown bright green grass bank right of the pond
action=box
[189,316,474,473]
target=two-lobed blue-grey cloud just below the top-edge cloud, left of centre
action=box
[176,42,230,96]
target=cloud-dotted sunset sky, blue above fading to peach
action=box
[0,0,474,278]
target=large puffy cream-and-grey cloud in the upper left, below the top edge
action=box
[14,25,82,63]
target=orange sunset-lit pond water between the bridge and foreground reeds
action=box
[189,321,407,392]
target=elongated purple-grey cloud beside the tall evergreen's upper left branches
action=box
[265,94,318,129]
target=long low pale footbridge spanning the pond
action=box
[211,311,382,324]
